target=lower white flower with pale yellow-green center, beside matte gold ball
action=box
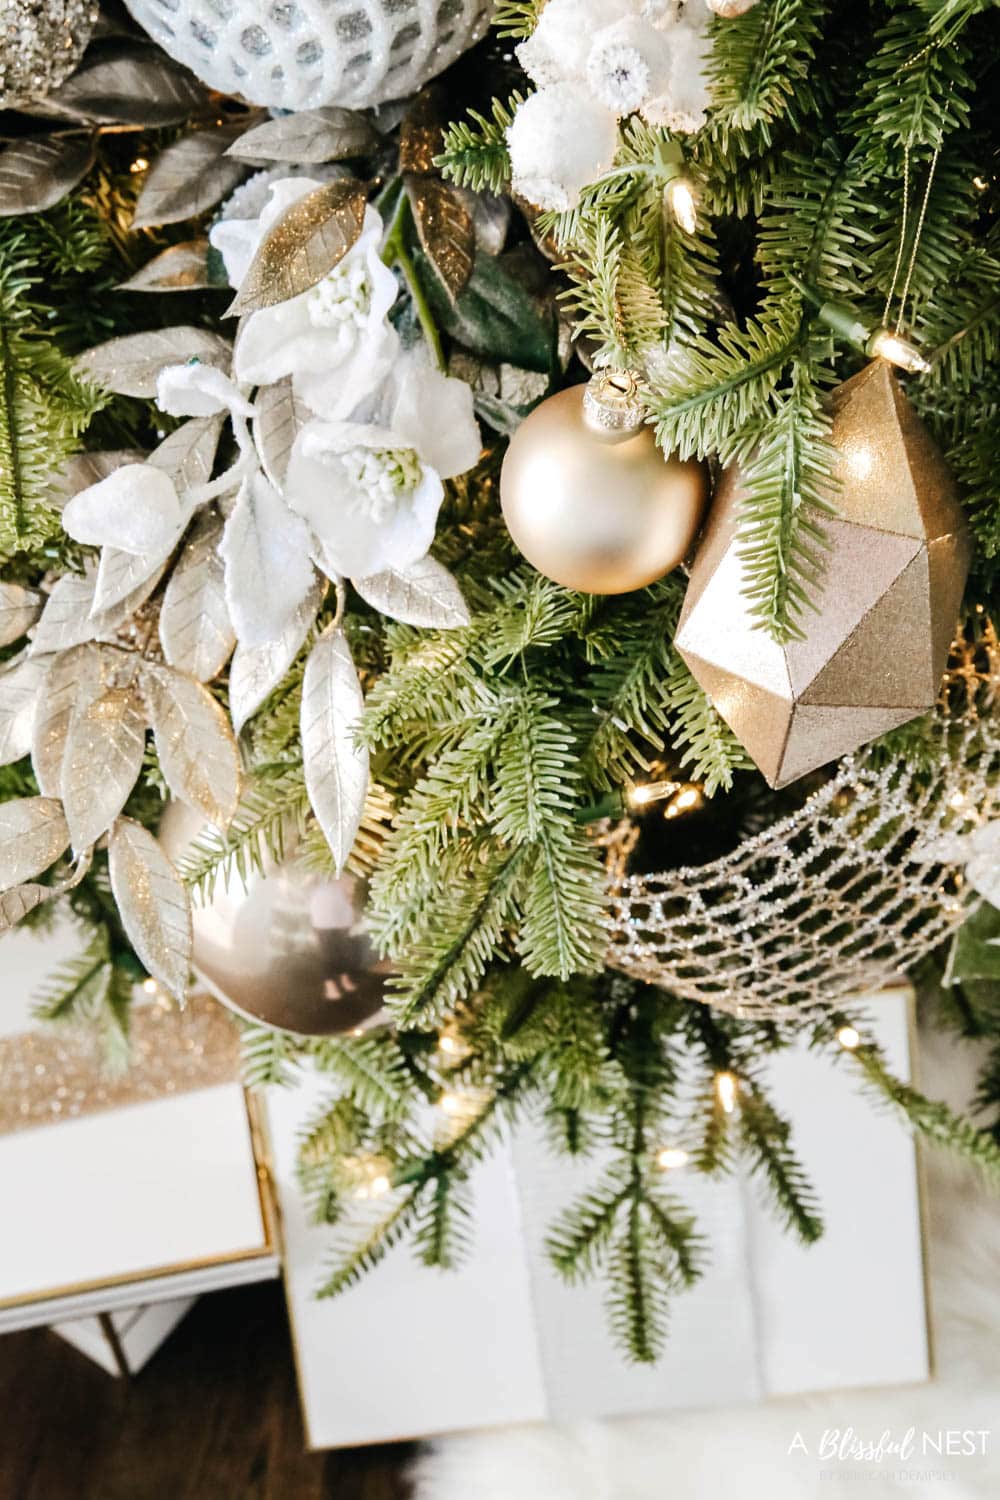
[285,356,480,578]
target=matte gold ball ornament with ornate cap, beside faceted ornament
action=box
[501,372,708,594]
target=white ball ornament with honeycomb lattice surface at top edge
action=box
[126,0,492,110]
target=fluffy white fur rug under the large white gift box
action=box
[414,1038,1000,1500]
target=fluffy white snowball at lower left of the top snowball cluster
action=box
[507,83,618,210]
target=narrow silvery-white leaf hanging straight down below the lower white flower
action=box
[300,627,369,875]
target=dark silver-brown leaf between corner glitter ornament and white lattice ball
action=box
[48,42,207,125]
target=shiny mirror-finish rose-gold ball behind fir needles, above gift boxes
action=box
[160,803,393,1037]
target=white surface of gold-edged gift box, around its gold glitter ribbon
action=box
[0,923,280,1349]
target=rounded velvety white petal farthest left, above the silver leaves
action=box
[61,464,189,555]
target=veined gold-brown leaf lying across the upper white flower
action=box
[228,177,367,315]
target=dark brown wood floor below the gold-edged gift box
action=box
[0,1284,414,1500]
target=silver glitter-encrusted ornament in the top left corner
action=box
[0,0,97,110]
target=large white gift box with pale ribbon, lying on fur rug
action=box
[267,989,928,1448]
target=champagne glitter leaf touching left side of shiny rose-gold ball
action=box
[108,818,192,1001]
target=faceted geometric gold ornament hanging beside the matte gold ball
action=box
[676,362,970,786]
